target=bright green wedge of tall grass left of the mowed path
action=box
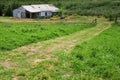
[0,22,95,51]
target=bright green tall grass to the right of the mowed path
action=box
[72,24,120,80]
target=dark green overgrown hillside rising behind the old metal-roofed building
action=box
[0,0,120,18]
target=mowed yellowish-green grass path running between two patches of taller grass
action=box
[0,17,111,80]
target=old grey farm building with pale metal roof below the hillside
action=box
[13,4,59,18]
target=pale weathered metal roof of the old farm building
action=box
[22,4,58,13]
